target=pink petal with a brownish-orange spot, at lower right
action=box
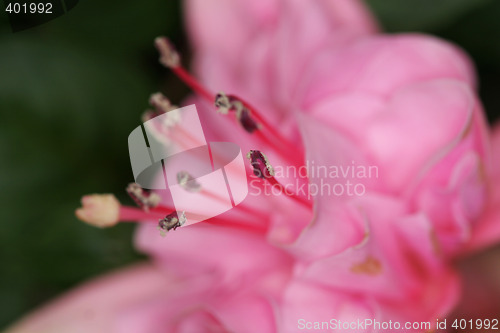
[303,195,419,298]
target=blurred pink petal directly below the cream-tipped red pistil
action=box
[135,223,291,293]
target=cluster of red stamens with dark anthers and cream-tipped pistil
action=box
[76,37,312,235]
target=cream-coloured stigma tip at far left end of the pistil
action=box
[75,194,120,228]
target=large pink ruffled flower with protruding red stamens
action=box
[6,0,500,333]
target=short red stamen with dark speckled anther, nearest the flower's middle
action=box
[247,150,312,209]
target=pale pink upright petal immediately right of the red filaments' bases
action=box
[286,114,377,260]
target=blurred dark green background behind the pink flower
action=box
[0,0,500,329]
